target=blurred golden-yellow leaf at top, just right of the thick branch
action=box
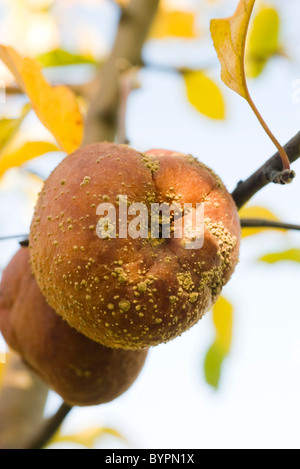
[150,8,196,39]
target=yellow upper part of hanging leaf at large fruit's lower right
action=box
[213,296,233,355]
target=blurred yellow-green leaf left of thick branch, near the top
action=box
[37,49,97,67]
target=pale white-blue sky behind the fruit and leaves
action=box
[0,0,300,449]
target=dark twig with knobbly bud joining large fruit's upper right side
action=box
[232,132,300,209]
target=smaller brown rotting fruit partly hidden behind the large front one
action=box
[0,248,147,406]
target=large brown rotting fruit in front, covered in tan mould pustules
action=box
[30,143,240,350]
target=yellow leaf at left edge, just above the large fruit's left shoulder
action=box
[0,142,59,177]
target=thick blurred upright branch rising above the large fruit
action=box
[83,0,159,144]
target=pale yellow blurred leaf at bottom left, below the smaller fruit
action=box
[47,427,123,449]
